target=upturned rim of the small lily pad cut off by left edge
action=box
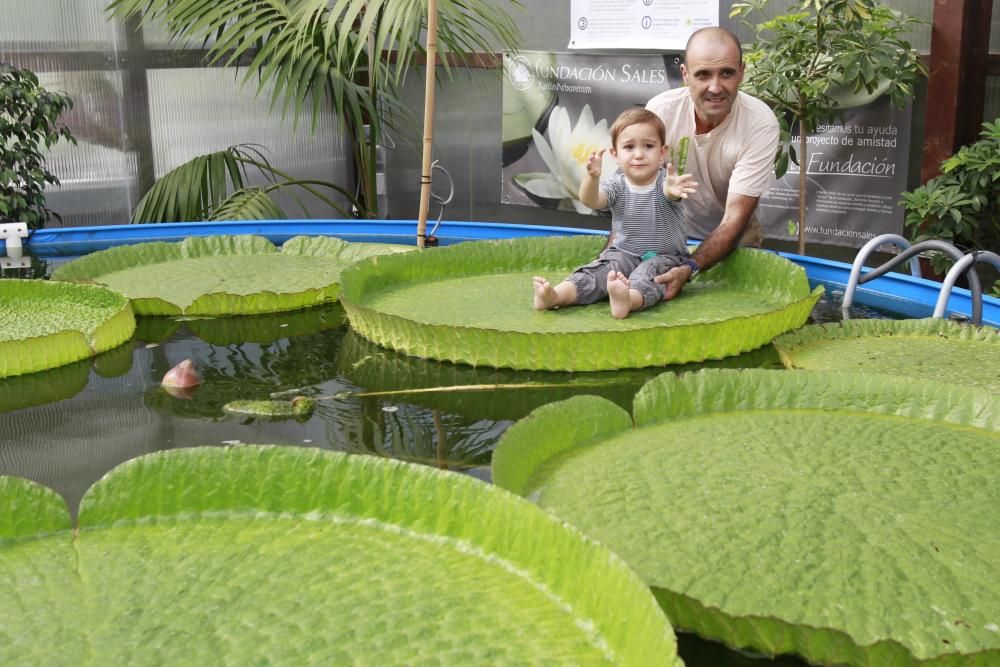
[0,278,135,378]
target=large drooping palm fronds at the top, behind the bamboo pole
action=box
[107,0,523,217]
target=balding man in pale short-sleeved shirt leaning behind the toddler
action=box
[646,27,779,300]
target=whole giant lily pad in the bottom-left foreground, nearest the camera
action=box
[0,446,678,665]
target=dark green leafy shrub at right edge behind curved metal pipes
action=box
[900,118,1000,294]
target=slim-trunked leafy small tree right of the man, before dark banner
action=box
[730,0,926,254]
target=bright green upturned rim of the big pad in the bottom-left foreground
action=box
[0,445,679,664]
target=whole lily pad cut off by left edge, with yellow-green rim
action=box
[0,279,135,378]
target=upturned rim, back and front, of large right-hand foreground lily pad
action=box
[492,369,1000,664]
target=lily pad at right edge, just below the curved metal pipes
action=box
[774,319,1000,393]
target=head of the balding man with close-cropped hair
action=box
[681,38,743,131]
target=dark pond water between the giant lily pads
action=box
[0,288,892,665]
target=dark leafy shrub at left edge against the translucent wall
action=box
[0,63,76,229]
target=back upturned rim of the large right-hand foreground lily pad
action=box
[492,368,1000,495]
